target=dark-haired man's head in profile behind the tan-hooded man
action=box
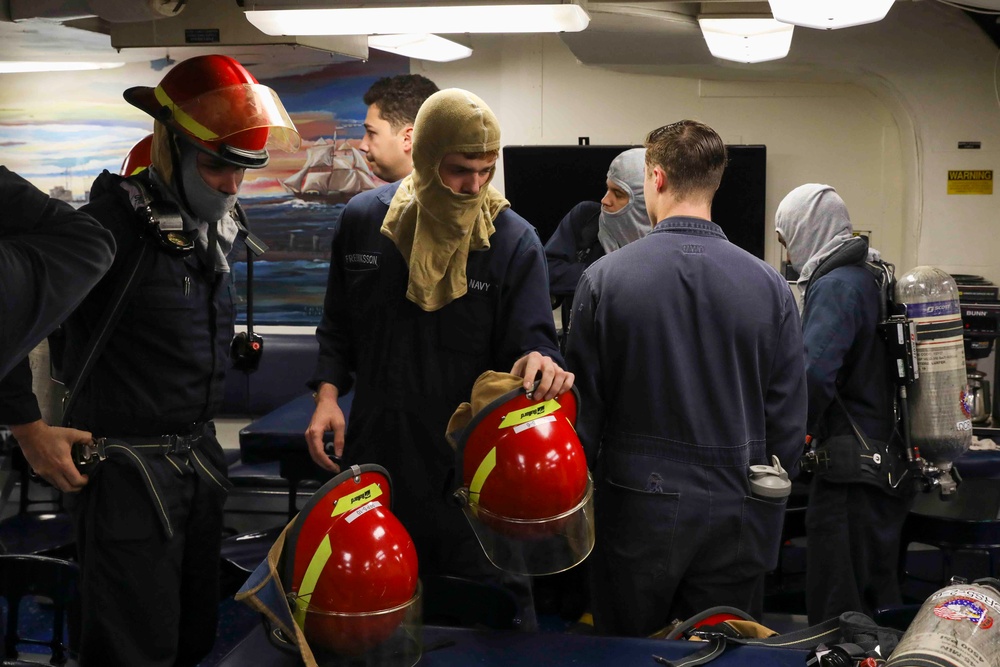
[358,74,438,183]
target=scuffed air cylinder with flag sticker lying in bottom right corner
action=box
[886,580,1000,667]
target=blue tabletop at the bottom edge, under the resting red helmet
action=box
[218,626,809,667]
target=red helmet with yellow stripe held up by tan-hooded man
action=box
[455,388,594,574]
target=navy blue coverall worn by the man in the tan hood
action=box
[310,184,562,604]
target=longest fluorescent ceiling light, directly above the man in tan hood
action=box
[246,4,590,35]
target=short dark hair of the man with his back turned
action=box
[646,120,726,201]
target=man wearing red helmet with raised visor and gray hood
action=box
[4,55,298,667]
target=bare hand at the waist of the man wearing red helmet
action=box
[10,419,93,493]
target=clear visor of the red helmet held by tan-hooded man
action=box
[462,473,594,575]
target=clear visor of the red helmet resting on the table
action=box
[288,583,423,667]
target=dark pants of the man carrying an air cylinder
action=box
[806,476,912,625]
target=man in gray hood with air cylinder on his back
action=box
[775,183,910,623]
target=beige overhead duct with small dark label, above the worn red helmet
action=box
[111,0,368,62]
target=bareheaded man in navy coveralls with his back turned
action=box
[567,120,806,636]
